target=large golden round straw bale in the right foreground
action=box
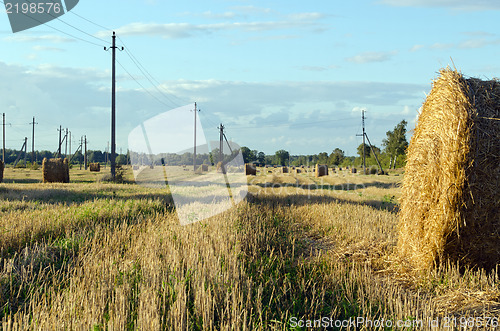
[398,69,500,269]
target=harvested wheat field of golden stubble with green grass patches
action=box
[0,168,500,330]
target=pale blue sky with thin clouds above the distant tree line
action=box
[0,0,500,155]
